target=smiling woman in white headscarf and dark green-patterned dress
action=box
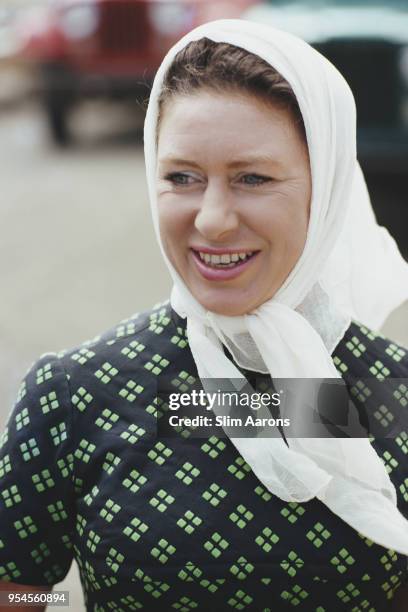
[0,20,408,612]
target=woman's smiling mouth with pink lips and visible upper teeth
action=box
[191,249,259,280]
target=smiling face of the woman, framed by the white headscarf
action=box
[157,90,311,316]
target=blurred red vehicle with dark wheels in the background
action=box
[20,0,257,145]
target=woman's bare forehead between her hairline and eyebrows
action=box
[158,92,306,167]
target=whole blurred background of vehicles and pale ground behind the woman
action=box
[0,0,408,611]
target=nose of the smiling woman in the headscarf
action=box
[194,185,239,240]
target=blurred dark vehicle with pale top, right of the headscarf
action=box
[243,0,408,173]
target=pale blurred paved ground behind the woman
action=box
[0,100,408,612]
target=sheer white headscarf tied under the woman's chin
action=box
[144,19,408,554]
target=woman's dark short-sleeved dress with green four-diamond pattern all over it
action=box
[0,302,408,612]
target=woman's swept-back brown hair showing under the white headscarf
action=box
[157,38,306,143]
